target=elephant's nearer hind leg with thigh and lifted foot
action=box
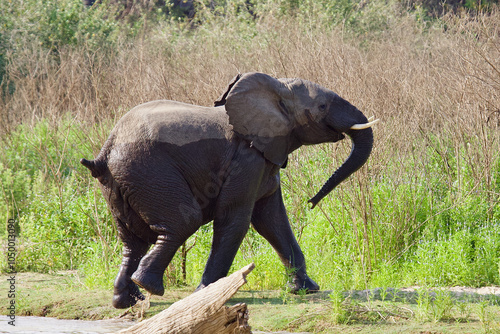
[128,162,203,296]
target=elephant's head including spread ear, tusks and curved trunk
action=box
[216,73,376,207]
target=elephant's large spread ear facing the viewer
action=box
[225,73,293,166]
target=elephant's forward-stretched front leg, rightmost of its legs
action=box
[252,187,319,292]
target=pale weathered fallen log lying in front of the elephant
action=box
[119,263,255,334]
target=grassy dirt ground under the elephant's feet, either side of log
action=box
[0,272,500,334]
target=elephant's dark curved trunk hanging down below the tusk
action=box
[309,128,373,208]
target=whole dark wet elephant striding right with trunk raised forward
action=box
[80,72,376,308]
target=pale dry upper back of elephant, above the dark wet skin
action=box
[112,100,232,146]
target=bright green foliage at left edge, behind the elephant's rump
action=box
[0,119,121,279]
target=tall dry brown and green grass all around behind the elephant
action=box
[0,1,500,289]
